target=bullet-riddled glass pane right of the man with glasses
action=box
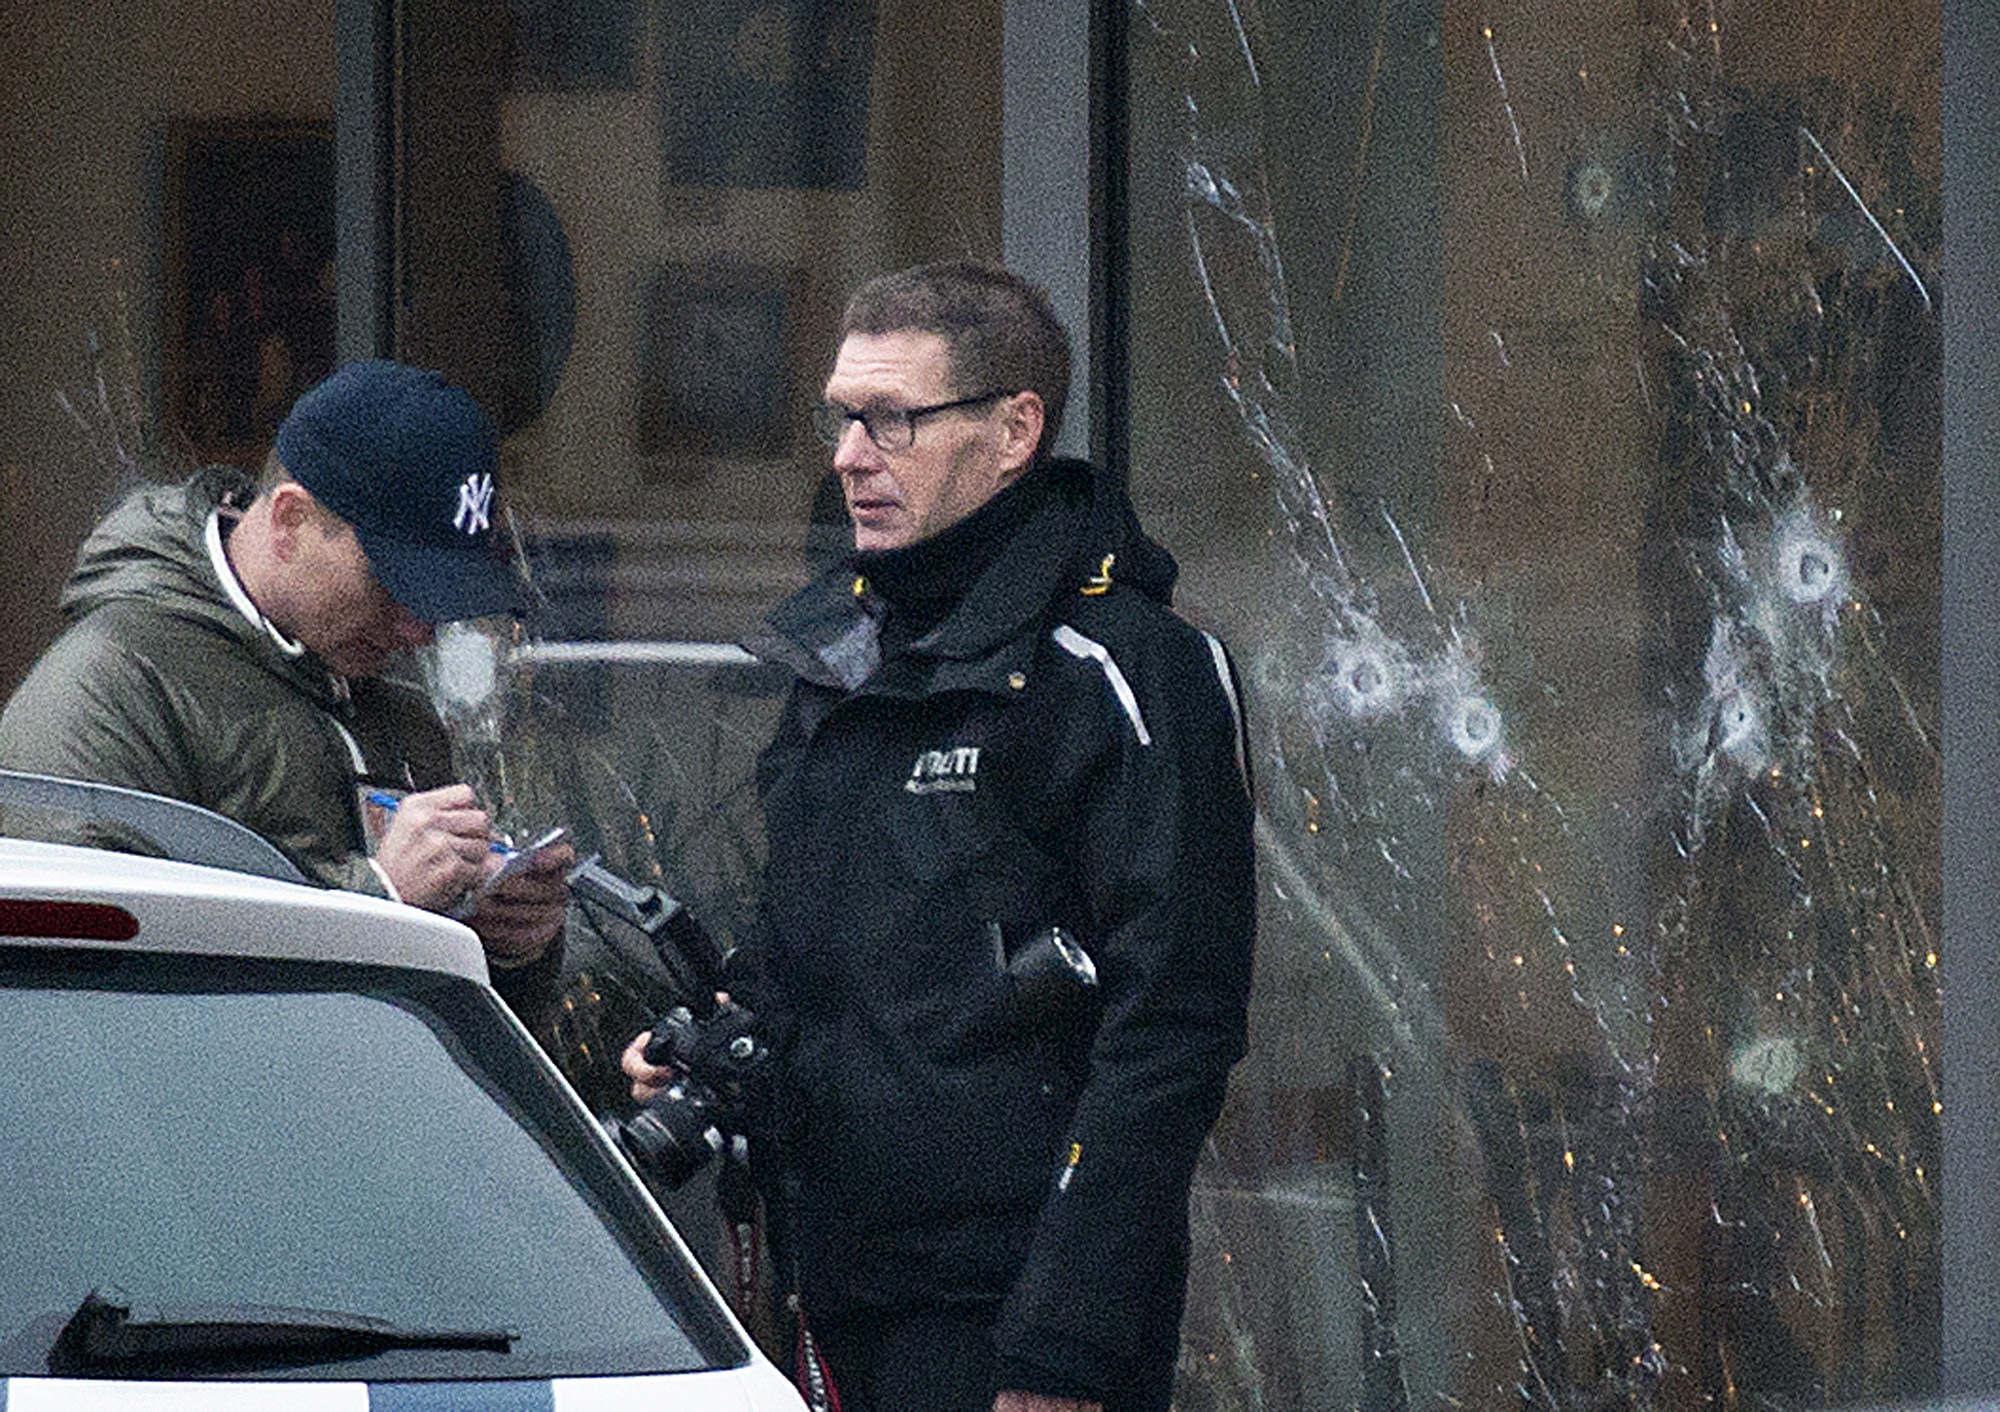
[1130,0,1942,1408]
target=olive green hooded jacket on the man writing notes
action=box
[0,470,452,896]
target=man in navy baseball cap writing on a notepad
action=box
[0,360,572,1002]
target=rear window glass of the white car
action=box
[0,946,748,1380]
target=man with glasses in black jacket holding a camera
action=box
[626,262,1254,1412]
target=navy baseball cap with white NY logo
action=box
[276,360,520,622]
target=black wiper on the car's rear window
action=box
[48,1290,520,1376]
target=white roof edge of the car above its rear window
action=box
[0,838,488,982]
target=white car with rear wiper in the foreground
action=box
[0,776,800,1412]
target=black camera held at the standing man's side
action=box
[616,1002,770,1188]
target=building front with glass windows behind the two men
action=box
[0,0,2000,1410]
